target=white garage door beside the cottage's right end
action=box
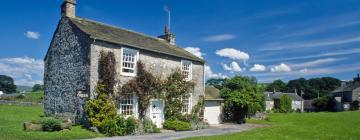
[204,101,221,124]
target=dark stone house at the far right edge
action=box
[332,74,360,111]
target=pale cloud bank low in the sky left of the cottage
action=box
[0,57,44,86]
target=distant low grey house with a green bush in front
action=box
[264,92,304,112]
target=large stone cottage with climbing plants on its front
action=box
[44,0,205,127]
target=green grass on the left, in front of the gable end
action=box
[0,105,101,140]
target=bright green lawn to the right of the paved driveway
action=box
[186,111,360,140]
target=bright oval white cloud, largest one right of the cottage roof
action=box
[216,48,250,61]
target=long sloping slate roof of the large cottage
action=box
[69,17,204,63]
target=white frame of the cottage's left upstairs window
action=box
[120,47,139,77]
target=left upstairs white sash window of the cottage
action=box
[121,48,139,76]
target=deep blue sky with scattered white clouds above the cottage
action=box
[0,0,360,85]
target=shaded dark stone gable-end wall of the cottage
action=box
[44,18,90,123]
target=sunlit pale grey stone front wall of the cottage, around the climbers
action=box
[90,41,205,112]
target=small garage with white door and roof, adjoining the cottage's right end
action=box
[204,86,224,125]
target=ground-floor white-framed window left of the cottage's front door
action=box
[119,94,137,116]
